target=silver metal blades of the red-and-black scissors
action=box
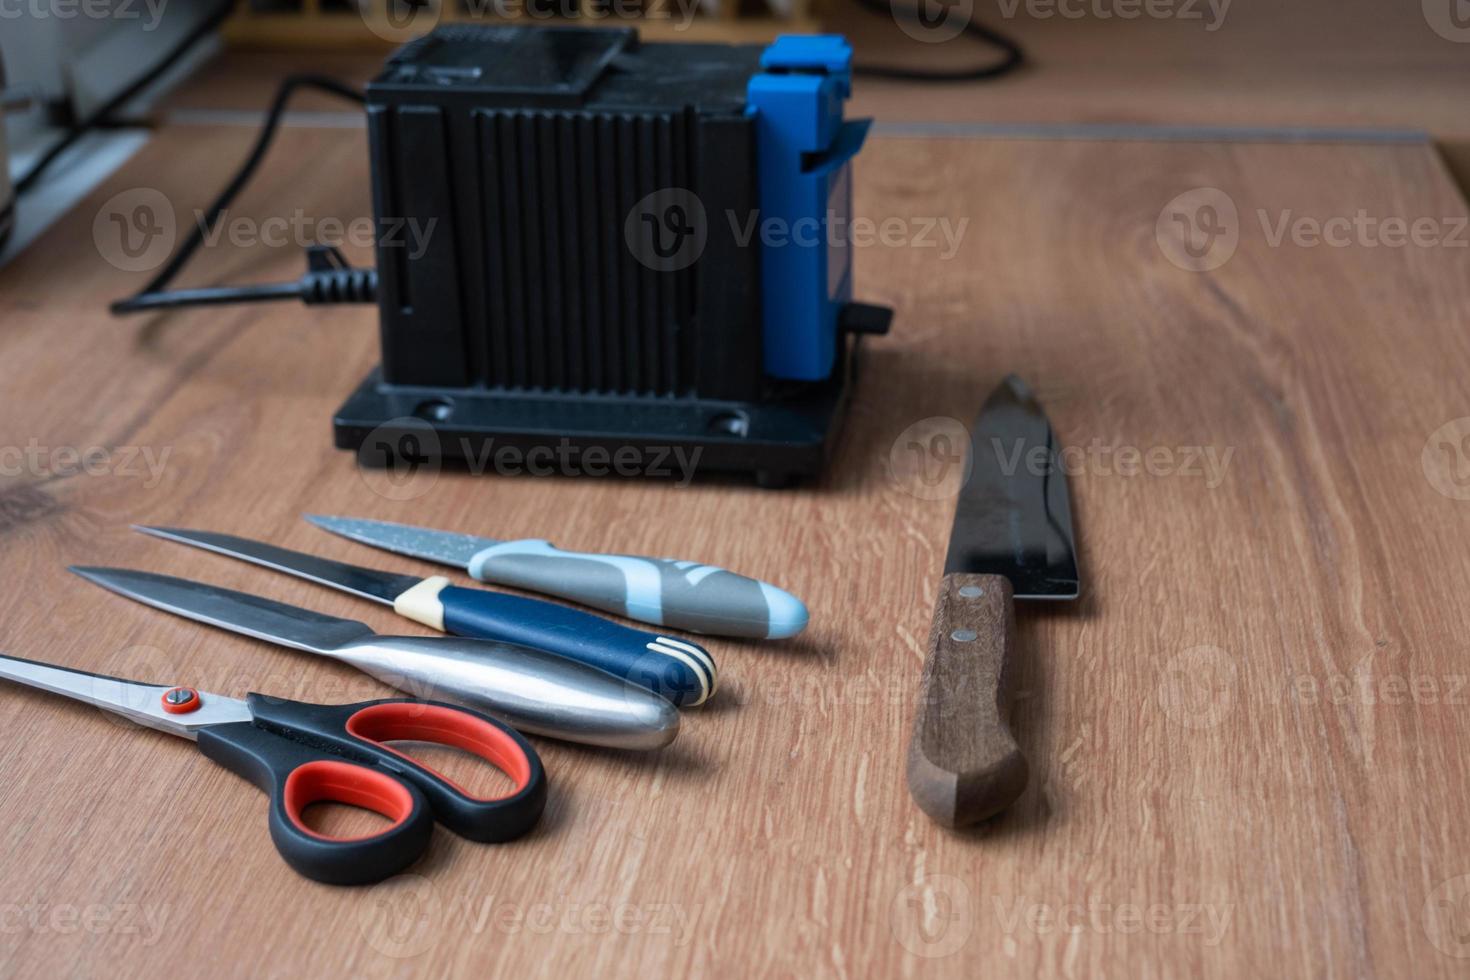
[0,657,253,739]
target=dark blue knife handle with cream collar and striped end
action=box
[392,576,717,707]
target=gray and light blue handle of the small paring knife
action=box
[466,539,807,639]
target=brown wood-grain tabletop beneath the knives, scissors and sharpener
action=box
[0,105,1470,979]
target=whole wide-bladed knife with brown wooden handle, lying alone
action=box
[907,375,1080,827]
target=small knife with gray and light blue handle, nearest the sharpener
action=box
[306,514,807,639]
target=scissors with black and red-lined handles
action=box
[0,657,547,884]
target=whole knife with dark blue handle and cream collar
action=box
[135,526,716,707]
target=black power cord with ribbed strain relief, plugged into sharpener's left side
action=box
[110,75,378,314]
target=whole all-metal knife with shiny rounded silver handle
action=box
[71,566,679,749]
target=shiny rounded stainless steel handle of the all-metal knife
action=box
[328,635,679,749]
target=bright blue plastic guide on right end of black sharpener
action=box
[747,34,872,381]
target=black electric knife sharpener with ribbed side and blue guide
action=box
[334,25,891,486]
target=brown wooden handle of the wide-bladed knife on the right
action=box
[908,574,1028,827]
